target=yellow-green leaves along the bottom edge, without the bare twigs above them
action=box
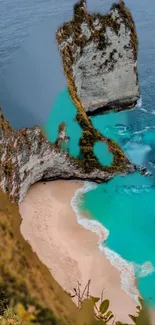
[0,296,150,325]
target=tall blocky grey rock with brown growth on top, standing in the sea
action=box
[57,0,139,114]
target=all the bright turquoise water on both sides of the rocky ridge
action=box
[45,86,155,306]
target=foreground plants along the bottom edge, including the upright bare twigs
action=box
[0,280,153,325]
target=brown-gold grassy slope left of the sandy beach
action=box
[0,191,76,325]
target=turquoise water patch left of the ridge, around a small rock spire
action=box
[44,89,82,157]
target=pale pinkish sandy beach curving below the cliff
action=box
[20,181,136,324]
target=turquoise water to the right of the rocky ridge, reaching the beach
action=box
[81,108,155,307]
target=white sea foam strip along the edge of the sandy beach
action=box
[71,182,155,303]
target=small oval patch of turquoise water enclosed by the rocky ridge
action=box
[94,142,113,166]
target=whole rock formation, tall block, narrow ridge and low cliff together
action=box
[0,0,142,203]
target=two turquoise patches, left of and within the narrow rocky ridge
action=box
[44,89,113,166]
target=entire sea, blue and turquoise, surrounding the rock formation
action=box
[0,0,155,306]
